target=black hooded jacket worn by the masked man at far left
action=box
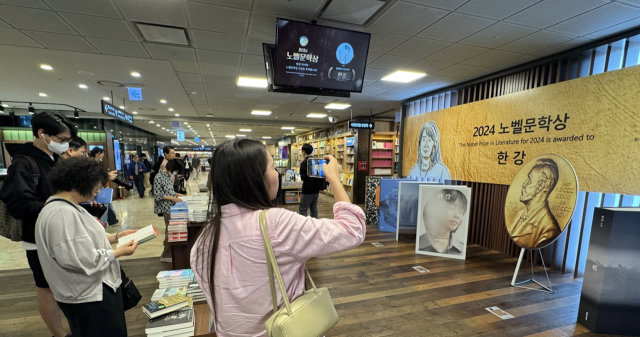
[0,143,58,243]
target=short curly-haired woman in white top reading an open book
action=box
[35,157,138,337]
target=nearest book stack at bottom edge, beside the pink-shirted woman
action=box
[144,308,196,337]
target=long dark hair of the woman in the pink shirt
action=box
[194,139,271,315]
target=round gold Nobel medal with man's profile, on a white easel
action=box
[504,154,578,249]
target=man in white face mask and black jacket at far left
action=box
[0,111,76,337]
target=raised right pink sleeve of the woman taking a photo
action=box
[267,202,366,262]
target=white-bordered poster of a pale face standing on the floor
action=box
[416,185,471,260]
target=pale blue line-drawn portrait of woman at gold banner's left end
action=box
[409,121,451,180]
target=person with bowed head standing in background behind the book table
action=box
[153,158,184,262]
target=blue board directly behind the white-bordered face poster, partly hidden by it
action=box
[396,181,442,241]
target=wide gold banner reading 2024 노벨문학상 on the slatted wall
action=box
[402,67,640,195]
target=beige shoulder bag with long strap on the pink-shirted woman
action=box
[260,210,340,337]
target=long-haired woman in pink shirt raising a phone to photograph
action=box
[191,139,366,337]
